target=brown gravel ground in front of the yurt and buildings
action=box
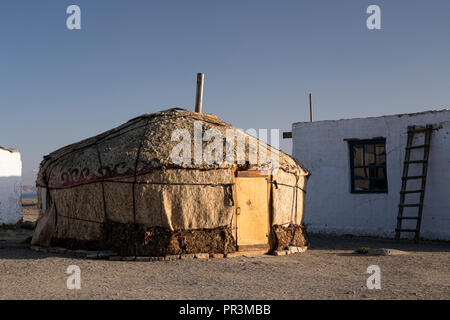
[0,222,450,299]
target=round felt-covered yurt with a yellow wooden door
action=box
[32,108,310,256]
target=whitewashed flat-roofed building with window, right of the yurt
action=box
[292,110,450,240]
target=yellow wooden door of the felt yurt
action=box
[236,177,270,251]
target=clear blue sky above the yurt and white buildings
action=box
[0,0,450,184]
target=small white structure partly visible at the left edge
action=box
[0,147,22,225]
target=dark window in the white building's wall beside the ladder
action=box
[349,139,387,193]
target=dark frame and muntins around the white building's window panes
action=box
[348,138,388,194]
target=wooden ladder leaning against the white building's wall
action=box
[395,125,433,243]
